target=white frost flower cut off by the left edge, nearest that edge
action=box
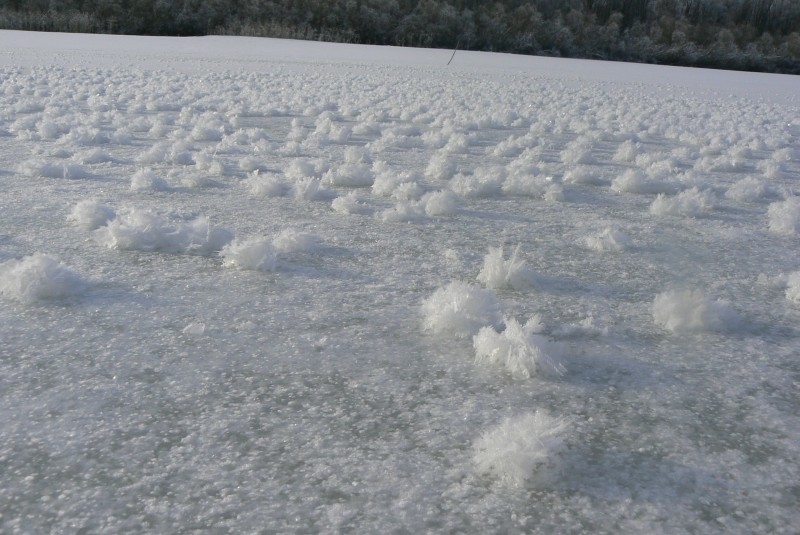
[0,253,88,303]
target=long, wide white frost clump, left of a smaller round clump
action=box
[94,208,233,255]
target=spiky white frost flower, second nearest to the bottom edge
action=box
[472,315,564,379]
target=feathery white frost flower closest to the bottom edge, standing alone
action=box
[472,410,569,487]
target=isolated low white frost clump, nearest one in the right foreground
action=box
[653,290,742,332]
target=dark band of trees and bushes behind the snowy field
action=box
[0,0,800,74]
